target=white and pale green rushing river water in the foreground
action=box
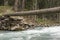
[0,26,60,40]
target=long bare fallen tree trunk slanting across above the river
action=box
[4,7,60,16]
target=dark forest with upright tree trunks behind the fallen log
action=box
[0,0,60,11]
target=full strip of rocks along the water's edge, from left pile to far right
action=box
[0,16,59,31]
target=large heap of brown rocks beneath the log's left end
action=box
[0,16,34,31]
